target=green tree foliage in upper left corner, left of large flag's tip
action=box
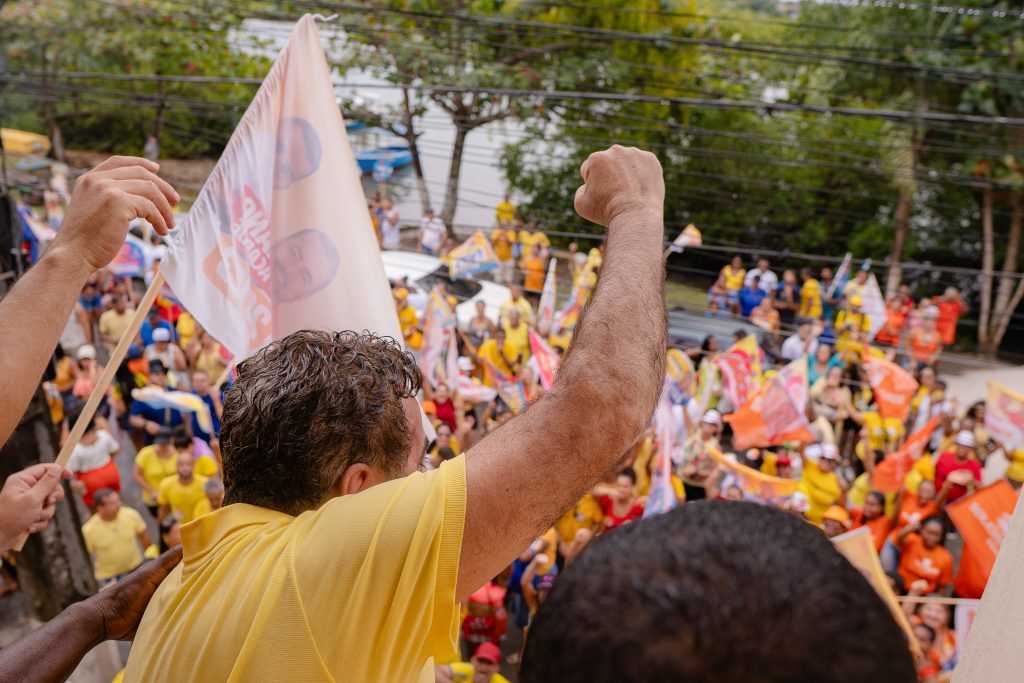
[0,0,269,158]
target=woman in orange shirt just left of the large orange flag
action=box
[897,517,953,595]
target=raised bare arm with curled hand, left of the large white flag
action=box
[0,157,178,444]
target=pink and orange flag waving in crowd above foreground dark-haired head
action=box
[725,357,814,450]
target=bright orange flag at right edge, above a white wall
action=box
[946,479,1017,598]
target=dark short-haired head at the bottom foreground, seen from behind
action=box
[519,502,916,683]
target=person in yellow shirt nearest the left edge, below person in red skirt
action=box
[82,488,150,586]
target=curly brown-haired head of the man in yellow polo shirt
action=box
[220,330,421,515]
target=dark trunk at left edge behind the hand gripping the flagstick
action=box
[0,390,96,621]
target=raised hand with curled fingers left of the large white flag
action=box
[53,157,178,270]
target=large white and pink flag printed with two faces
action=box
[162,16,402,359]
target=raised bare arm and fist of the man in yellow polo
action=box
[458,145,666,598]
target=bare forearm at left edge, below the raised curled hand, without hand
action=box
[0,245,92,444]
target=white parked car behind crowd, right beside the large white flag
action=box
[381,251,511,328]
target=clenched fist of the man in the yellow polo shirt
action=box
[575,144,665,226]
